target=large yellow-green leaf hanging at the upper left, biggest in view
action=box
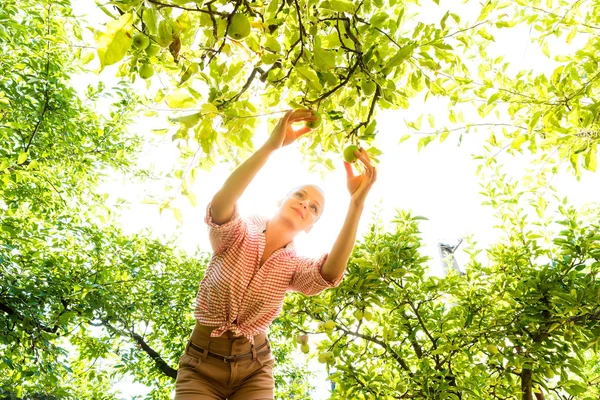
[97,13,133,71]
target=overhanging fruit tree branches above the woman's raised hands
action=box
[88,0,600,216]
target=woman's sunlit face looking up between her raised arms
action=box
[279,185,325,232]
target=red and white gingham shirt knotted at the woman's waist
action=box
[194,204,343,342]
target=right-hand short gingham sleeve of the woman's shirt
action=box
[288,253,344,296]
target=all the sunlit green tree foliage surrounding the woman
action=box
[0,0,600,400]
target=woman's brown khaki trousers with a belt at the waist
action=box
[175,323,275,400]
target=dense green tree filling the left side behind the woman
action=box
[0,1,308,399]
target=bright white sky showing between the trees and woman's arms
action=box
[74,1,600,399]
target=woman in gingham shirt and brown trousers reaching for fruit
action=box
[175,110,377,400]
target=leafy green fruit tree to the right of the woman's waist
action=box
[284,167,600,400]
